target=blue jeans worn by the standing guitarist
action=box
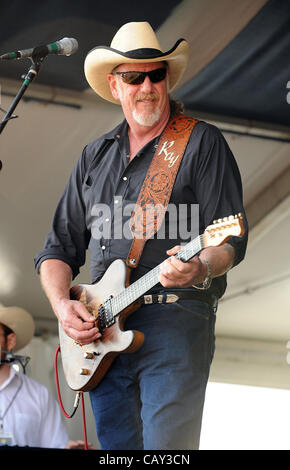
[90,300,215,450]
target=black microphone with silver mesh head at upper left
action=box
[0,38,79,60]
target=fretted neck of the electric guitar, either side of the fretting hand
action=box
[112,235,204,316]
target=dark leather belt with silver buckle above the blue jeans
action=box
[141,290,217,307]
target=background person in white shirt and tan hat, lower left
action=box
[0,305,92,449]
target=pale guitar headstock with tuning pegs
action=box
[203,214,245,248]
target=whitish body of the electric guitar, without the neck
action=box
[59,260,144,391]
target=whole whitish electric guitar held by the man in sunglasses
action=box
[59,214,245,391]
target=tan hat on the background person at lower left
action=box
[0,304,35,351]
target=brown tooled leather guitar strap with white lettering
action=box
[126,114,198,268]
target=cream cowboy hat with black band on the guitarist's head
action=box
[84,22,189,104]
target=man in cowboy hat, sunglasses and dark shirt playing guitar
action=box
[35,22,247,449]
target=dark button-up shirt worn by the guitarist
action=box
[35,121,247,298]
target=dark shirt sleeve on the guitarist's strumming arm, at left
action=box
[34,147,90,278]
